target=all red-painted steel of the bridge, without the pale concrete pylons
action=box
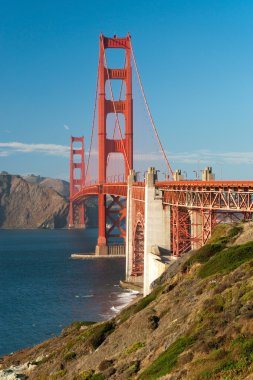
[70,34,253,258]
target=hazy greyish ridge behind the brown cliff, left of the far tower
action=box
[22,174,69,198]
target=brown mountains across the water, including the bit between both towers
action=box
[0,172,98,229]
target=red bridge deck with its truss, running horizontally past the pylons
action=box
[72,180,253,212]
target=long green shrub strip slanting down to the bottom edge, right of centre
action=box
[139,336,196,380]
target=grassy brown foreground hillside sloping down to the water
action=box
[0,224,253,380]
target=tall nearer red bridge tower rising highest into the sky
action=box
[96,34,133,255]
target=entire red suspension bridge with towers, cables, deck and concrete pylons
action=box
[69,34,253,292]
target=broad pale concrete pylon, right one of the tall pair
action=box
[143,168,170,295]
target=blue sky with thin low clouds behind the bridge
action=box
[0,0,253,180]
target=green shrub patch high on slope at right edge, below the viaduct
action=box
[198,242,253,278]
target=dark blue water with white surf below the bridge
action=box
[0,229,134,355]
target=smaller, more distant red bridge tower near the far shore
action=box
[69,136,86,227]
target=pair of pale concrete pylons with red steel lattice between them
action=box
[126,168,170,295]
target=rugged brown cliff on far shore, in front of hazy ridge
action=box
[0,174,69,228]
